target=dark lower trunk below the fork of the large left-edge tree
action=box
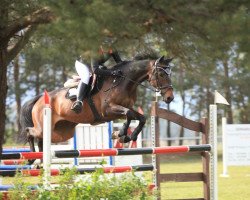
[0,48,8,154]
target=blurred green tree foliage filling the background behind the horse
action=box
[2,0,250,144]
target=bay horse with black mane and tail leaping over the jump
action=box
[20,56,174,164]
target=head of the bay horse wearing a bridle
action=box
[148,56,174,103]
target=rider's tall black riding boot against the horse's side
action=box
[71,82,88,114]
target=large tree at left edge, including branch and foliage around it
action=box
[0,0,54,153]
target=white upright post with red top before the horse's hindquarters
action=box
[43,90,51,188]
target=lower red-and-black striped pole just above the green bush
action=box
[0,164,154,177]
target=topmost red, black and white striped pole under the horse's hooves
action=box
[1,144,211,160]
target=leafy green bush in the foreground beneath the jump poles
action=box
[4,169,152,200]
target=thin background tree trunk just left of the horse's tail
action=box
[14,56,21,134]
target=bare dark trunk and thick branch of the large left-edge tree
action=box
[0,5,54,154]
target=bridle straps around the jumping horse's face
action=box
[149,60,173,91]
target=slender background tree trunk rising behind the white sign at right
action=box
[223,60,233,124]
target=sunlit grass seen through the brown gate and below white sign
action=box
[146,156,250,200]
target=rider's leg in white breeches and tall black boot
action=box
[71,61,90,113]
